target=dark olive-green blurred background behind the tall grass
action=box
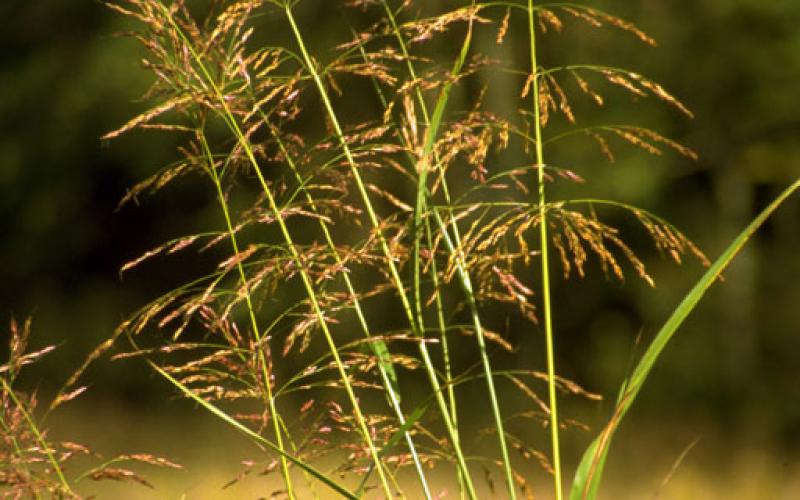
[0,0,800,499]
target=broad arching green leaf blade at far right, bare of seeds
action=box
[570,179,800,500]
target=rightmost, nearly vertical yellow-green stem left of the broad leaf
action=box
[528,0,563,500]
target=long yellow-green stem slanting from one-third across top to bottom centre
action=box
[284,4,477,499]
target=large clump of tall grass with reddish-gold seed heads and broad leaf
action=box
[98,0,797,499]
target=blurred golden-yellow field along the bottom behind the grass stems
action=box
[53,402,800,500]
